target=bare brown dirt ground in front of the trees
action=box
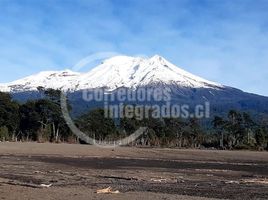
[0,143,268,200]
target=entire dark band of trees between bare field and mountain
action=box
[0,89,268,150]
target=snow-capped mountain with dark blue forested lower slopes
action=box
[0,55,268,116]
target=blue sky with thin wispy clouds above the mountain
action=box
[0,0,268,96]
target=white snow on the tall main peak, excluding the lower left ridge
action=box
[78,56,222,89]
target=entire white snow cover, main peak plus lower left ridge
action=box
[0,55,224,92]
